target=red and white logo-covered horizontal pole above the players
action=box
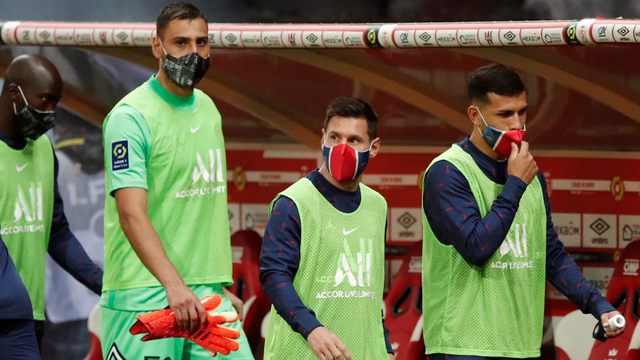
[0,19,640,49]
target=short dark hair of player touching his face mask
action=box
[467,64,524,104]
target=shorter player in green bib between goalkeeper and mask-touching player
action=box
[260,97,394,360]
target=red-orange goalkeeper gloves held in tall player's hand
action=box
[129,295,240,356]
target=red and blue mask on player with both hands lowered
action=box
[322,140,373,182]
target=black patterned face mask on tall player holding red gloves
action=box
[160,41,210,88]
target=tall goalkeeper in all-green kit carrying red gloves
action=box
[100,3,253,360]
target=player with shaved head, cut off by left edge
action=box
[0,54,102,350]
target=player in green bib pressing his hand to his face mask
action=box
[422,64,624,360]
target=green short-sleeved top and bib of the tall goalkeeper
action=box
[103,77,233,292]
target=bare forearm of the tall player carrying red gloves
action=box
[120,211,183,288]
